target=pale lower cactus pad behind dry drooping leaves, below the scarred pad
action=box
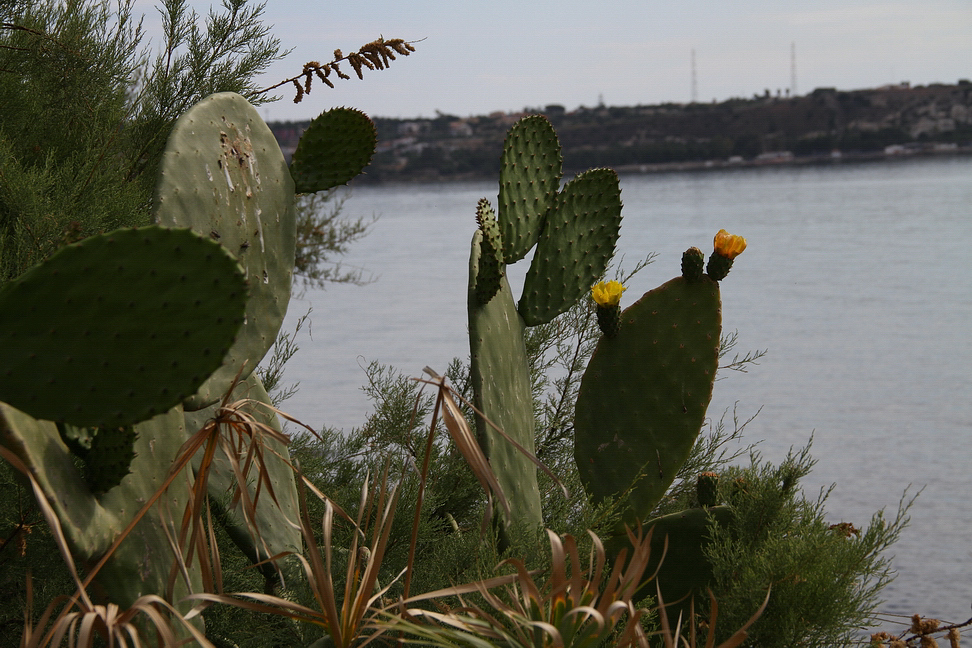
[185,373,303,573]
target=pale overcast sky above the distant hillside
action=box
[136,0,972,120]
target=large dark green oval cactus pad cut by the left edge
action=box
[0,227,247,428]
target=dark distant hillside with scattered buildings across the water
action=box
[270,80,972,182]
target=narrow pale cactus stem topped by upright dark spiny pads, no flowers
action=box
[468,117,621,526]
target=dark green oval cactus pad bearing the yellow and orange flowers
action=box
[574,277,722,524]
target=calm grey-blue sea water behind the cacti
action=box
[274,157,972,621]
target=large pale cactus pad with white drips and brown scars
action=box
[155,92,296,410]
